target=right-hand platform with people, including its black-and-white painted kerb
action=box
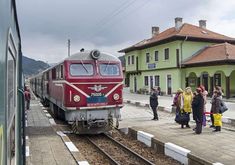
[120,104,235,165]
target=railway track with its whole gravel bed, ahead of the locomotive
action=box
[48,106,180,165]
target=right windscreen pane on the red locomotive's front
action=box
[99,64,120,76]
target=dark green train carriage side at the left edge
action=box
[0,0,25,165]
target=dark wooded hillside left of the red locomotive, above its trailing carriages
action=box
[22,56,49,77]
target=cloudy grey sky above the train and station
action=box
[16,0,235,63]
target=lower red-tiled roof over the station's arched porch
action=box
[183,43,235,65]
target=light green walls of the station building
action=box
[125,40,235,95]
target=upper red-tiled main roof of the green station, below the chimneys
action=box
[119,23,235,52]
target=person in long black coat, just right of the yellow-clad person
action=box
[192,88,204,134]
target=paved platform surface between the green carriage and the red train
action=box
[26,100,78,165]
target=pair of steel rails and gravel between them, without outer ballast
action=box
[86,134,154,165]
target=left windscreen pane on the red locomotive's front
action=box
[70,64,94,76]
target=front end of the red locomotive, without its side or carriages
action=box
[63,50,123,134]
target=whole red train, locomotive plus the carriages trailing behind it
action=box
[30,50,123,134]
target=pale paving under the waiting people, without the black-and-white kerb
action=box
[119,104,235,165]
